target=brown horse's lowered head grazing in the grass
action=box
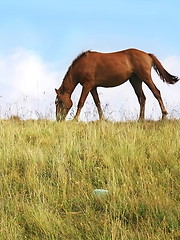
[55,89,72,121]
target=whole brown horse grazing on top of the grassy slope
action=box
[55,49,179,121]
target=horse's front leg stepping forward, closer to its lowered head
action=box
[74,84,92,120]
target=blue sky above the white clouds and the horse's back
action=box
[0,0,180,61]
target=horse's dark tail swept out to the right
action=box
[149,53,179,84]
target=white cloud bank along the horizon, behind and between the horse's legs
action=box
[0,48,180,120]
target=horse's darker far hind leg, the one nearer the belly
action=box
[129,75,146,120]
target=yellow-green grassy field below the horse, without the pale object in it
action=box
[0,119,180,240]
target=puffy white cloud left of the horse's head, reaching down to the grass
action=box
[0,48,60,118]
